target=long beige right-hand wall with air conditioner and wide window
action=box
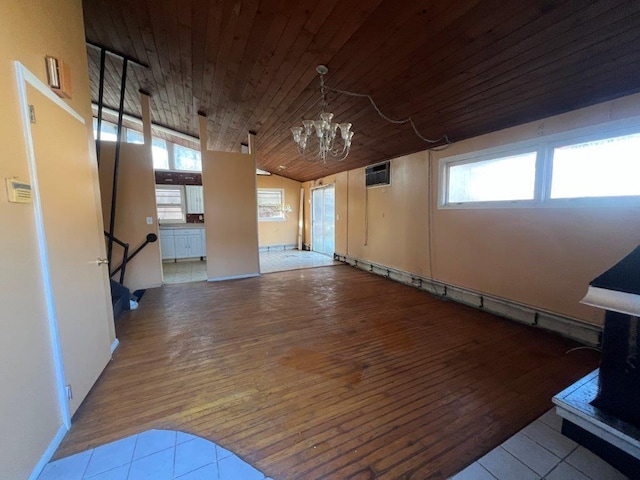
[305,95,640,324]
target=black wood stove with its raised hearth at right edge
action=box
[553,247,640,478]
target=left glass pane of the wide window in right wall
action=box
[447,152,537,203]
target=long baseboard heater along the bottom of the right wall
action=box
[333,253,602,347]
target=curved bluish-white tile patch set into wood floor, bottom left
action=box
[38,430,271,480]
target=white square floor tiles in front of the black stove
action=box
[452,410,627,480]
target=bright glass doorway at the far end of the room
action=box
[311,185,336,256]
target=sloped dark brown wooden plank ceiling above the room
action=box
[83,0,640,181]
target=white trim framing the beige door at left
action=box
[15,62,88,430]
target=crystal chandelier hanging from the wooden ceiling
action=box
[291,65,353,163]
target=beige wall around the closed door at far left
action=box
[0,0,107,479]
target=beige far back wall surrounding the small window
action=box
[257,175,302,247]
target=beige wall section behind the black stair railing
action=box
[100,142,162,292]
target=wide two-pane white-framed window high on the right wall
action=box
[439,123,640,208]
